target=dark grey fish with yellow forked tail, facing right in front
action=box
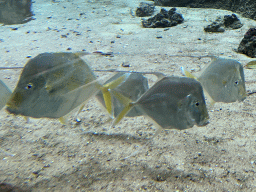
[112,76,209,130]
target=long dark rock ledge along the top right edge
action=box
[151,0,256,20]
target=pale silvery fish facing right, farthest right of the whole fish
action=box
[184,56,246,104]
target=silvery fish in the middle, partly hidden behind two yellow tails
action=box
[96,71,149,118]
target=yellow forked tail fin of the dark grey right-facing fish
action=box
[112,90,134,126]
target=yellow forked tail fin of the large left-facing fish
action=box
[101,75,126,115]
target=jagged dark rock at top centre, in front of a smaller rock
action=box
[142,8,184,28]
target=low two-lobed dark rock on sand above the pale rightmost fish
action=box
[204,14,243,32]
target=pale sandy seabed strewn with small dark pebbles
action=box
[0,0,256,191]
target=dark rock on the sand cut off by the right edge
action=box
[237,28,256,58]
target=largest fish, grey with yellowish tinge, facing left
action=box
[6,52,121,124]
